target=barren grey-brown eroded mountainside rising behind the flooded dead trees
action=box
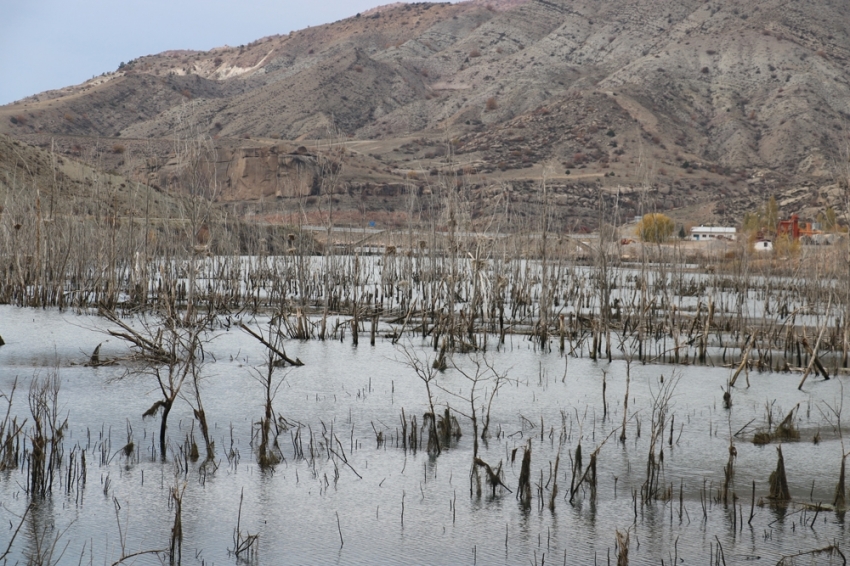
[0,0,850,231]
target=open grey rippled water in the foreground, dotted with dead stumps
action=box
[0,306,850,565]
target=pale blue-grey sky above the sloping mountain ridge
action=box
[0,0,438,105]
